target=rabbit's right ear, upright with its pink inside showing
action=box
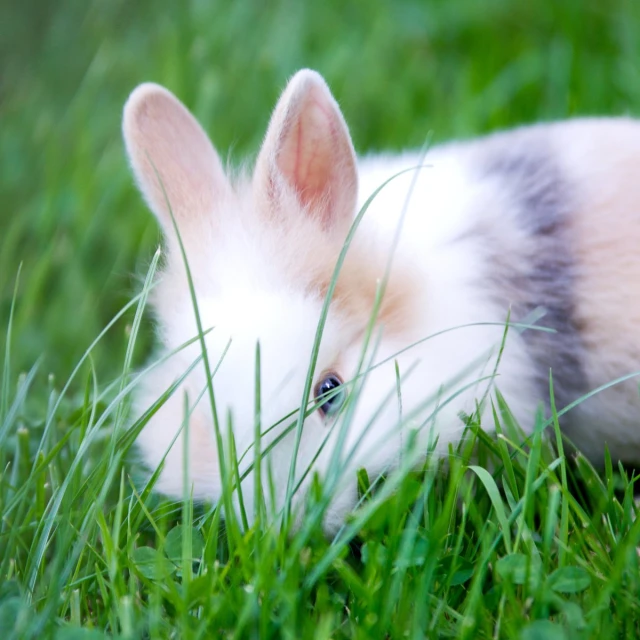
[254,69,358,235]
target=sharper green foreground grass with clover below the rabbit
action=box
[0,302,640,638]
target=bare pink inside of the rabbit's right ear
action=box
[277,90,350,225]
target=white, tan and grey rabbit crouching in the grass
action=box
[123,69,640,531]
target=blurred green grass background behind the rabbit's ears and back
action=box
[0,0,640,381]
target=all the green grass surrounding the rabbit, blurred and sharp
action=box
[0,0,640,640]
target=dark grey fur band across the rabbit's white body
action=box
[482,136,588,410]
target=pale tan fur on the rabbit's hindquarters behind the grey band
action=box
[558,120,640,428]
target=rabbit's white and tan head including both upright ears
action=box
[123,70,430,529]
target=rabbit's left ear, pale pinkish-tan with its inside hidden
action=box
[122,83,229,238]
